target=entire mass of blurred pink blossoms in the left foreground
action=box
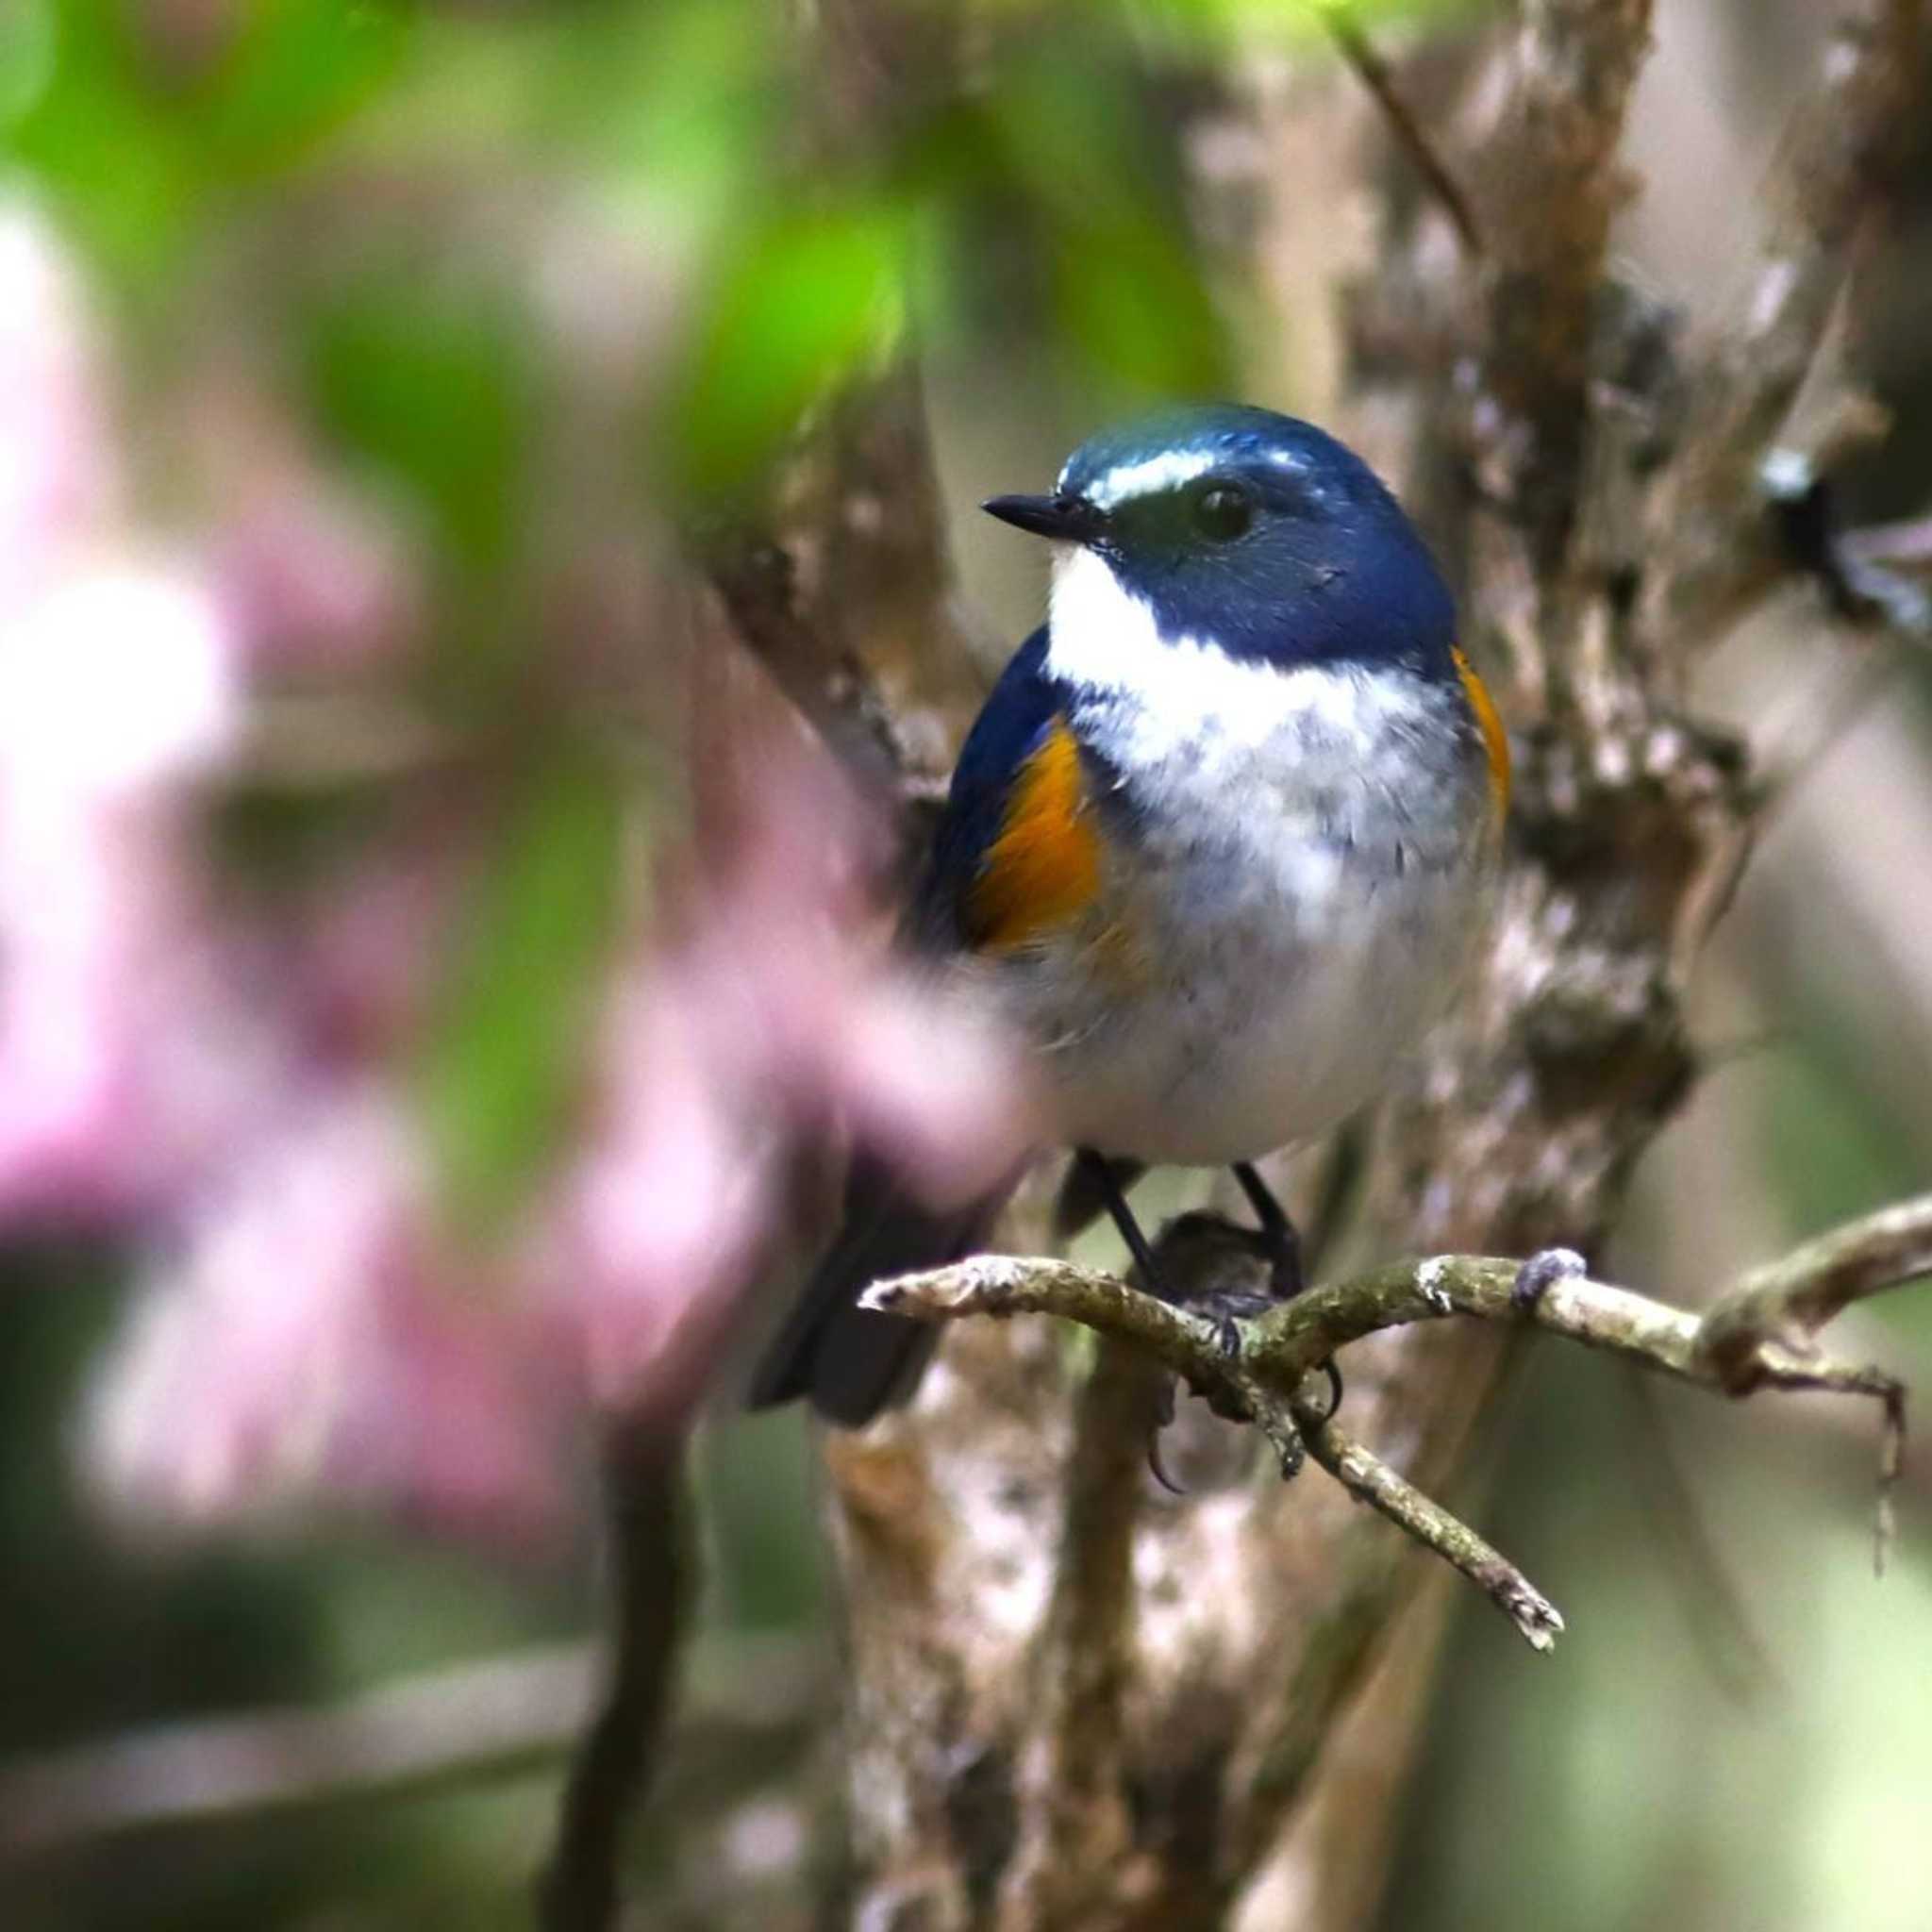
[0,188,1028,1528]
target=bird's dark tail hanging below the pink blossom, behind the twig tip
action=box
[750,1158,1010,1430]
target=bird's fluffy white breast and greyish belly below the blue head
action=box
[1008,551,1493,1165]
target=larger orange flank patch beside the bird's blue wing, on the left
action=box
[972,719,1099,953]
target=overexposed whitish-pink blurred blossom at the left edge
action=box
[0,205,272,1217]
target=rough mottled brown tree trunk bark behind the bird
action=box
[703,0,1919,1932]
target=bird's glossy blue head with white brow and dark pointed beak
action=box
[985,404,1457,678]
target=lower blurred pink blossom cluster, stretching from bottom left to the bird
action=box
[94,726,1024,1528]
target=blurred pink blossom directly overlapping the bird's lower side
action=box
[570,690,1030,1410]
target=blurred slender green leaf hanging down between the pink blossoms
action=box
[419,754,620,1241]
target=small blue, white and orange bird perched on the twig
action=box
[752,406,1508,1425]
